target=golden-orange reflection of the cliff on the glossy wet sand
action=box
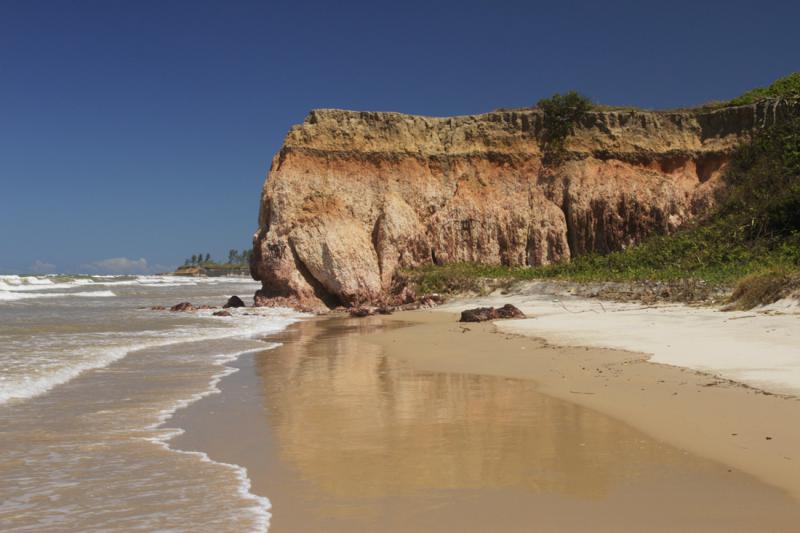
[257,319,678,499]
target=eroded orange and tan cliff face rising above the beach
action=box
[251,103,776,308]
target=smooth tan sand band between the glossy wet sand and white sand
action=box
[376,311,800,501]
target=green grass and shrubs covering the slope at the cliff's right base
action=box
[407,113,800,301]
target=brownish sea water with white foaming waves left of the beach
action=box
[0,275,302,531]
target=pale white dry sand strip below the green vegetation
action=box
[439,283,800,395]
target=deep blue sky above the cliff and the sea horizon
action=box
[0,0,800,272]
